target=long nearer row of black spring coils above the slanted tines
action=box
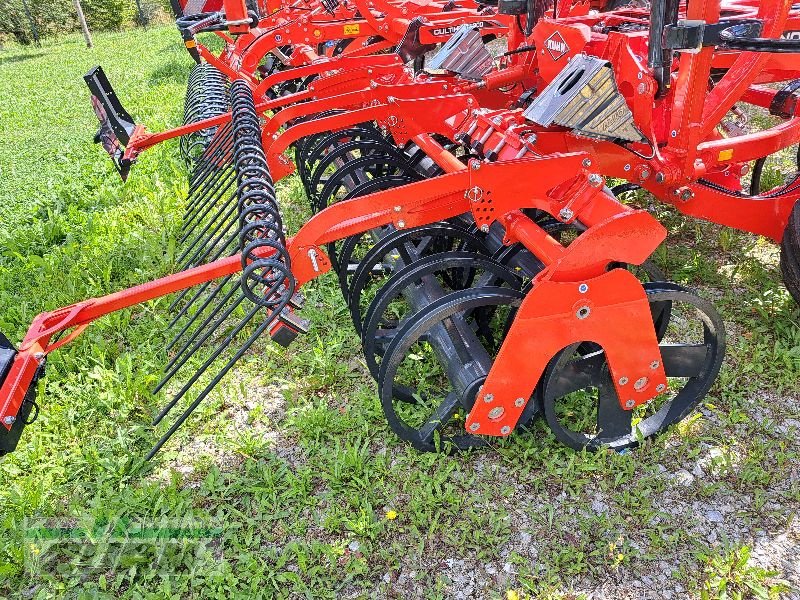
[230,80,295,310]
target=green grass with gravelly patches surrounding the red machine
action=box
[0,28,800,598]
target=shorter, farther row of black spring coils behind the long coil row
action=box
[181,63,228,162]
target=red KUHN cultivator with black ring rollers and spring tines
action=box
[0,0,800,456]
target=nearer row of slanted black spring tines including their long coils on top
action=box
[148,81,295,460]
